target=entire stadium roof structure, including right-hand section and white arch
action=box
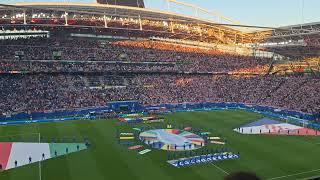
[0,0,320,58]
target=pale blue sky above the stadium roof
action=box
[4,0,320,27]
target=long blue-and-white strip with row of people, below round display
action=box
[167,152,240,168]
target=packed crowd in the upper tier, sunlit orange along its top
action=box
[0,38,271,72]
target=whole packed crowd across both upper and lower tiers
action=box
[0,38,320,114]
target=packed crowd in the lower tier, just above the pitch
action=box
[0,74,320,114]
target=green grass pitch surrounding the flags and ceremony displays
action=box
[0,110,320,180]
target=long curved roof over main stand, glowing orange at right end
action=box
[0,2,271,55]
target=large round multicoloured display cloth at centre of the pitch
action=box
[139,129,204,151]
